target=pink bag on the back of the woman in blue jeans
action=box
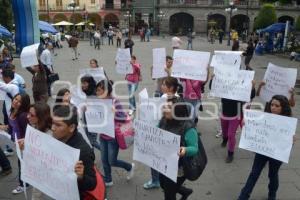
[115,114,134,149]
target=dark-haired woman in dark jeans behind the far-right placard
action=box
[238,95,292,200]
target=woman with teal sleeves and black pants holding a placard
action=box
[158,97,198,200]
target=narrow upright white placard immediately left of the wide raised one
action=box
[152,48,168,78]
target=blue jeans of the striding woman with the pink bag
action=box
[100,138,132,183]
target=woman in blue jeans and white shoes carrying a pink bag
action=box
[96,80,134,186]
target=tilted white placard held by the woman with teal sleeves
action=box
[133,120,180,182]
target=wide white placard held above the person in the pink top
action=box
[171,49,210,81]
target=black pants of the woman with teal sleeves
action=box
[159,174,185,200]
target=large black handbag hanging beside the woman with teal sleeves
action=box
[182,130,207,181]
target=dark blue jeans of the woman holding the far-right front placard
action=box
[239,153,282,200]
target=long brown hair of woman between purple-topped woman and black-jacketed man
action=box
[30,101,52,132]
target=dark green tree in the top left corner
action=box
[0,0,13,30]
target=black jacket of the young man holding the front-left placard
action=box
[66,130,97,199]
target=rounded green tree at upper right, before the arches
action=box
[254,4,277,29]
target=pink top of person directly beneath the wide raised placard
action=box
[180,79,203,99]
